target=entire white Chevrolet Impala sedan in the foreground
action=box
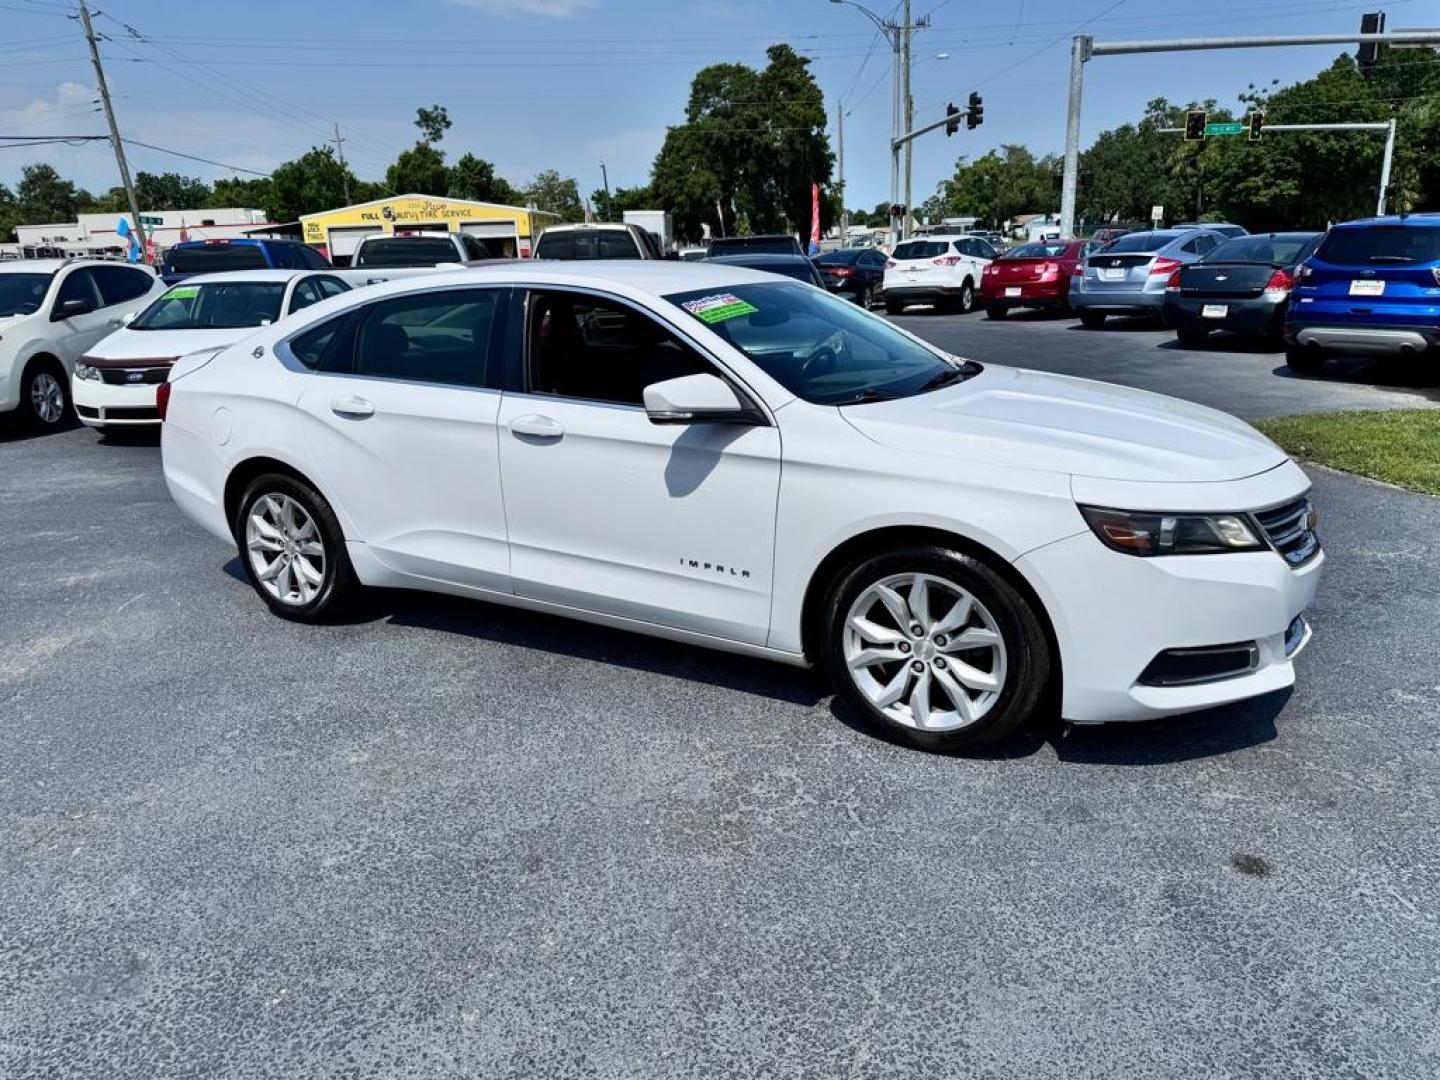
[158,261,1325,749]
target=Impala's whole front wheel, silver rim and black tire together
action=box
[822,547,1051,750]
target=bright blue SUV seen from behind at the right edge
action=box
[1284,213,1440,374]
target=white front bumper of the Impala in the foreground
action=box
[1015,492,1325,724]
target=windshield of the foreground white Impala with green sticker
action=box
[665,282,981,405]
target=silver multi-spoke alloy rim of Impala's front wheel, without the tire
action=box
[844,573,1005,732]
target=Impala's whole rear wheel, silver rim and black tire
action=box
[235,474,359,622]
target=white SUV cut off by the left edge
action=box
[0,259,166,431]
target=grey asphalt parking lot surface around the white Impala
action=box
[0,314,1440,1080]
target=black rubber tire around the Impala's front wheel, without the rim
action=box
[819,547,1053,753]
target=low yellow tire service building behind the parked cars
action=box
[300,194,560,266]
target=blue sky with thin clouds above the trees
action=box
[0,0,1416,207]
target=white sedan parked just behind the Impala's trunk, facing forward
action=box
[71,269,350,432]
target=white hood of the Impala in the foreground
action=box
[840,367,1287,482]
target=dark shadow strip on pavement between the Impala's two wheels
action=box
[345,584,829,707]
